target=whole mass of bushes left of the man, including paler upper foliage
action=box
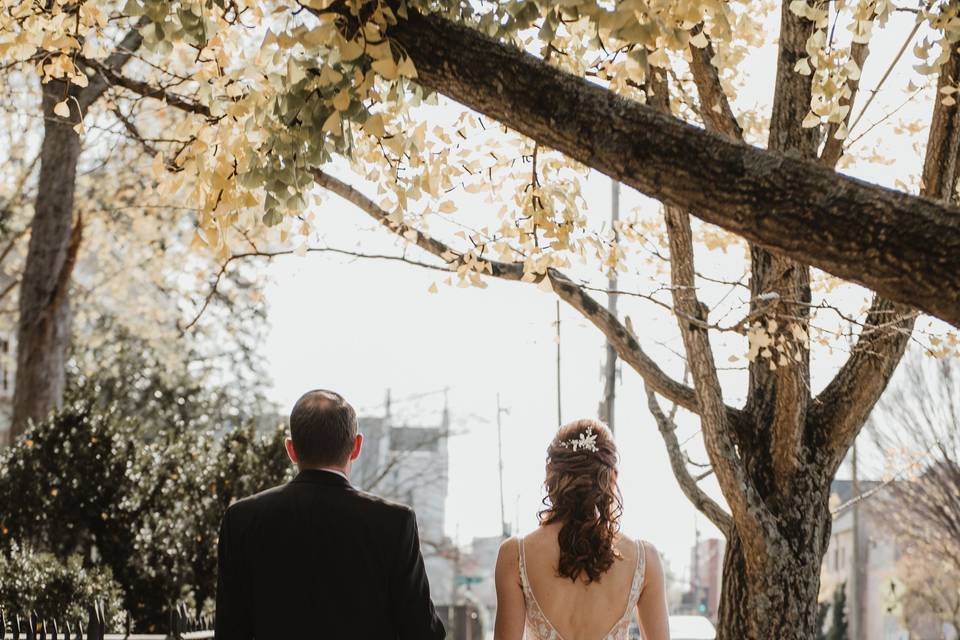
[0,336,293,631]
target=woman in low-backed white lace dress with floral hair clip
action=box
[494,420,669,640]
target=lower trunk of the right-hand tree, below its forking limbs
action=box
[717,473,832,640]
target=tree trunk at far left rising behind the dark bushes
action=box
[11,81,80,436]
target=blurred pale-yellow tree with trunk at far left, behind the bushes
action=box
[0,21,262,436]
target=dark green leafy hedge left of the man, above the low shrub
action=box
[0,396,292,631]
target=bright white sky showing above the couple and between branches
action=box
[256,2,944,576]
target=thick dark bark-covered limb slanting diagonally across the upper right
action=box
[378,10,960,326]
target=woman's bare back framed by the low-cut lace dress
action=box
[517,524,644,640]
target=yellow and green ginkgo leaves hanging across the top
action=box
[0,0,960,366]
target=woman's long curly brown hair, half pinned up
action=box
[538,420,623,583]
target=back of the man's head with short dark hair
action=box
[290,389,357,467]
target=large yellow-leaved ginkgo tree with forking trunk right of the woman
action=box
[0,0,960,640]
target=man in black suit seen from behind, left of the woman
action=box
[216,390,445,640]
